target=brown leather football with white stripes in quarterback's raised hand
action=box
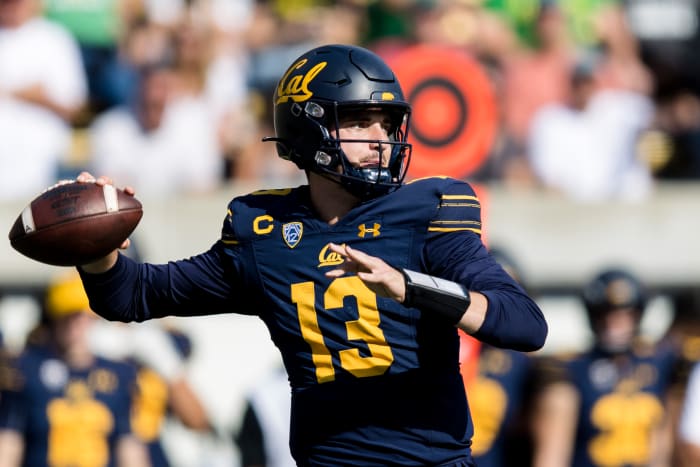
[9,181,143,266]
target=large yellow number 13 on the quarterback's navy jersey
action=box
[292,276,394,383]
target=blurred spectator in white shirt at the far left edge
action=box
[0,0,87,200]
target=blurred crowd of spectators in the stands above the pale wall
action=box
[0,0,700,205]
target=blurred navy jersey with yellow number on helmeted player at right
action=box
[563,346,677,467]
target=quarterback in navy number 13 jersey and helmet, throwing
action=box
[78,45,547,466]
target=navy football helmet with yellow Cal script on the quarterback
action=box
[264,45,411,199]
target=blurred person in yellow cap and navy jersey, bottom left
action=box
[0,273,149,467]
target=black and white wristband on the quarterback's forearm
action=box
[401,269,471,324]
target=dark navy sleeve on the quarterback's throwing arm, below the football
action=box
[78,243,246,322]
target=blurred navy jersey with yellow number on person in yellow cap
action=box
[0,347,135,467]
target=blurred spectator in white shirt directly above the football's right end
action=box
[90,62,223,197]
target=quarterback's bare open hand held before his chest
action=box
[326,243,406,302]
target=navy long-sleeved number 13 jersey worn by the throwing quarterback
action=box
[83,178,546,466]
